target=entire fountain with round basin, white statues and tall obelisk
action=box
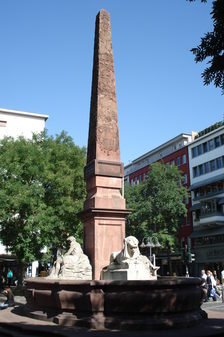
[25,10,206,330]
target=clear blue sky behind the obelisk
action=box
[0,0,224,164]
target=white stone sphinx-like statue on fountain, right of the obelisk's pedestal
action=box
[101,236,159,280]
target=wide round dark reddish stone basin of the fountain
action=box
[24,277,207,330]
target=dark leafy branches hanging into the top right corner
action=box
[190,0,224,94]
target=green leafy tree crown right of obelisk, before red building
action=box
[125,163,188,250]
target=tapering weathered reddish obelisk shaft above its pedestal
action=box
[87,10,120,163]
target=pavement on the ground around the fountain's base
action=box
[0,296,224,337]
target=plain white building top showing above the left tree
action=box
[0,108,48,139]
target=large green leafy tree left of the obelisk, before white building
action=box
[0,132,86,276]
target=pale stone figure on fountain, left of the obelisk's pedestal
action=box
[48,236,92,280]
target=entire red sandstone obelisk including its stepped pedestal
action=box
[82,10,128,279]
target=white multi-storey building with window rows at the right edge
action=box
[188,123,224,271]
